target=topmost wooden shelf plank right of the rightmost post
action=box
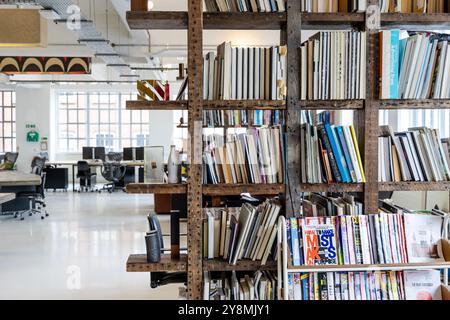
[381,13,450,30]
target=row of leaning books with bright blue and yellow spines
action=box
[300,112,366,183]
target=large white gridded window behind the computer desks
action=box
[57,92,150,152]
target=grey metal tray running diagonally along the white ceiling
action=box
[0,0,139,79]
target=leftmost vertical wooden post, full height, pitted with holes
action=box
[187,0,203,300]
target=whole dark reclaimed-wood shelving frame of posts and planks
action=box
[127,0,450,299]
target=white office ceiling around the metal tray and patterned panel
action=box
[0,0,279,86]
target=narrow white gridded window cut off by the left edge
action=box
[0,91,16,152]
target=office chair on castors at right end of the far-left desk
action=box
[14,157,49,221]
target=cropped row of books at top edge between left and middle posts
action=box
[204,0,286,12]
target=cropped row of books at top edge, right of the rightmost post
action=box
[380,0,450,13]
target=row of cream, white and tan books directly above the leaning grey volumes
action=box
[203,126,286,184]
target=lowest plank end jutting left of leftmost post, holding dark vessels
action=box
[127,254,187,272]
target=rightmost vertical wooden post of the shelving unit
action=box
[364,0,379,214]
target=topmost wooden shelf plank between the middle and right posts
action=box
[301,12,365,30]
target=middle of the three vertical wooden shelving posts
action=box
[282,0,302,216]
